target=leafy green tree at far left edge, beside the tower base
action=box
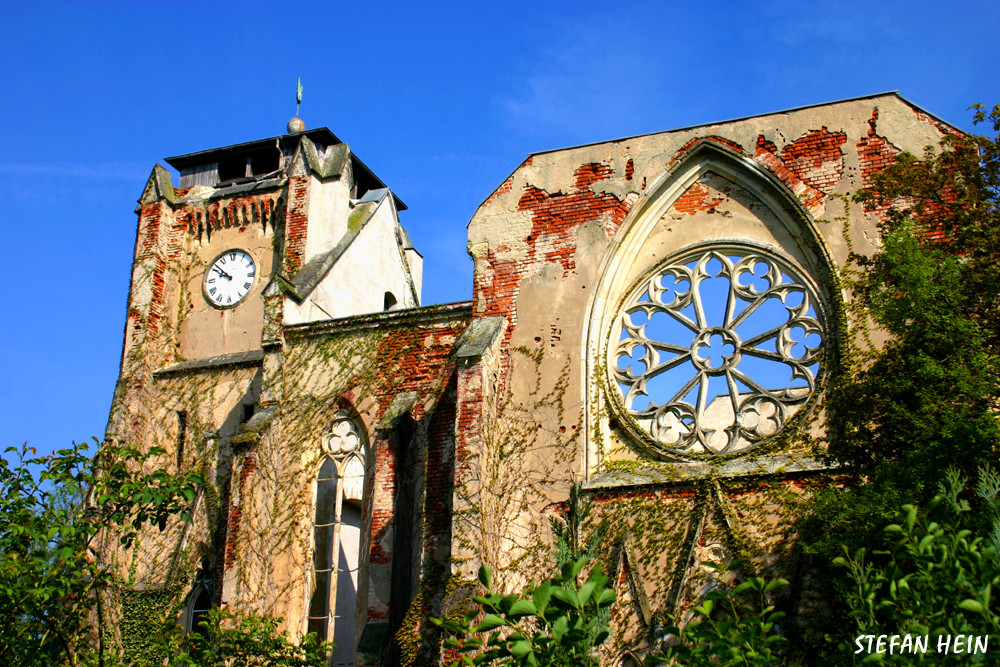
[0,444,202,666]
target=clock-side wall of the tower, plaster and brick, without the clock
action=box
[106,165,279,592]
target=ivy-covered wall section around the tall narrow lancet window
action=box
[223,305,468,638]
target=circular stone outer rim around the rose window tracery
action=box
[600,239,836,463]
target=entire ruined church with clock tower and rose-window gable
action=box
[106,93,957,666]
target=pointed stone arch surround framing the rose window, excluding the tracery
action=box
[584,138,841,472]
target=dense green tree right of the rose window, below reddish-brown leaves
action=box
[830,222,1000,491]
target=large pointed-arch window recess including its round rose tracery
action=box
[585,141,837,470]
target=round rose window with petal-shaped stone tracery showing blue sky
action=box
[610,246,825,458]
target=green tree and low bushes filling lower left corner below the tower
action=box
[0,443,340,667]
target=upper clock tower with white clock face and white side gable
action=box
[116,124,422,386]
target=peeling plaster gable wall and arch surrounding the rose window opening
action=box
[458,94,954,632]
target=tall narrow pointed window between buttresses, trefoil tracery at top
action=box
[307,410,367,665]
